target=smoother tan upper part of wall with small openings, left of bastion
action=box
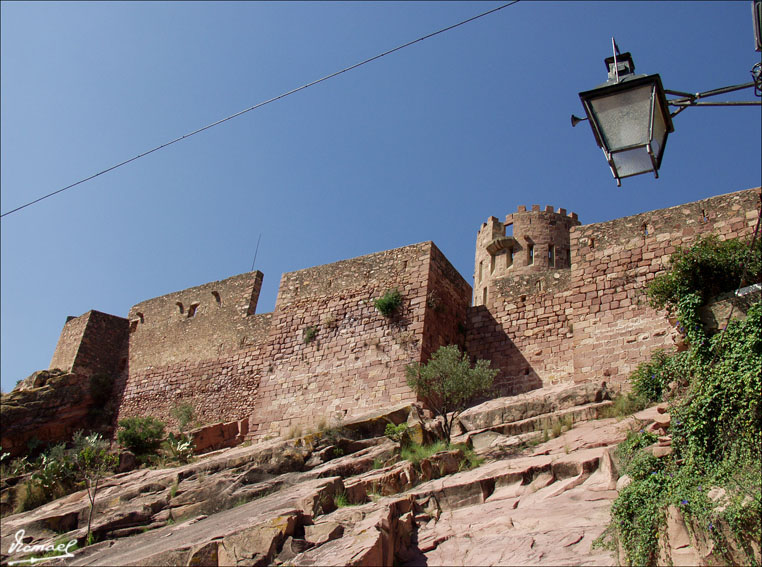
[128,271,267,375]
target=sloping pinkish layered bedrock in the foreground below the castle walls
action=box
[0,386,700,565]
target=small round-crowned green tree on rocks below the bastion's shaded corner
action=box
[406,345,498,443]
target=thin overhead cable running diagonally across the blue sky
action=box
[0,0,519,218]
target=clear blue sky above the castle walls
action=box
[0,0,760,391]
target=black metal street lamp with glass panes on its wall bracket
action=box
[571,38,762,186]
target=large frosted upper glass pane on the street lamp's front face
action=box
[590,85,652,151]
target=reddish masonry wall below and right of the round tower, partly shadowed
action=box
[467,188,760,394]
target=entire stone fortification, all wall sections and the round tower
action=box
[44,188,760,439]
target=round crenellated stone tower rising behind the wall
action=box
[474,205,580,305]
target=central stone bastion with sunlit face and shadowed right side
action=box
[250,242,471,438]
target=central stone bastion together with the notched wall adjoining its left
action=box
[117,242,471,438]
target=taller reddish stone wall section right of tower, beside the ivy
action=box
[569,188,760,381]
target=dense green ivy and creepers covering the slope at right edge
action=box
[596,238,762,565]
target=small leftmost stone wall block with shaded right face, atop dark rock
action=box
[50,310,129,376]
